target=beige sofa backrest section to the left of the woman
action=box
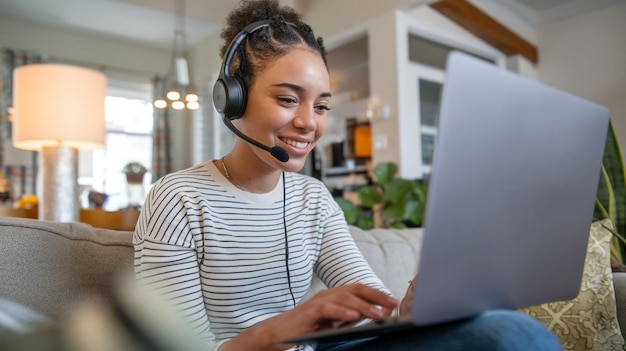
[0,218,133,319]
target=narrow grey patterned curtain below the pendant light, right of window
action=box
[152,76,172,183]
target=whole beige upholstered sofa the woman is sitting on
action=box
[0,218,626,349]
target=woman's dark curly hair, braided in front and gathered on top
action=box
[220,0,328,91]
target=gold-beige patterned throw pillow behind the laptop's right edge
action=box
[520,220,624,350]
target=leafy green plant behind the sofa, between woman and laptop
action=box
[335,162,426,229]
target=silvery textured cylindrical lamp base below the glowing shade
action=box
[39,146,80,222]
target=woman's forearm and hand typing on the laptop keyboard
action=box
[222,284,398,351]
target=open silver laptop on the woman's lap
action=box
[288,52,609,343]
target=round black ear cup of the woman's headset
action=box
[213,77,247,120]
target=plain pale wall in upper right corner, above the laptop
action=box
[538,1,626,150]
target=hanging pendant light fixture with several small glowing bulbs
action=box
[154,0,200,110]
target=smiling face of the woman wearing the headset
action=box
[237,48,330,172]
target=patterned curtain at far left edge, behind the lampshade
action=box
[0,48,47,200]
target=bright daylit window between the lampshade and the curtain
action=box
[79,81,153,211]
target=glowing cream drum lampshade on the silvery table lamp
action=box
[13,64,107,150]
